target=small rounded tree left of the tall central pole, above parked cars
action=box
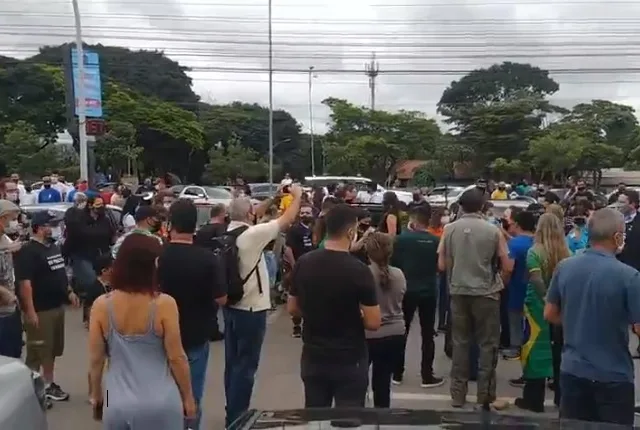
[204,136,269,184]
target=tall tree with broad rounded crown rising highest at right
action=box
[438,62,564,168]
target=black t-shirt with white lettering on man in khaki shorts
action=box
[14,240,69,312]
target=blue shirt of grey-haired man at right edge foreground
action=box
[547,248,640,383]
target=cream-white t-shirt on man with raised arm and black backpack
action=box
[227,220,280,312]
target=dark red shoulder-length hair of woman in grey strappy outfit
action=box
[111,233,162,294]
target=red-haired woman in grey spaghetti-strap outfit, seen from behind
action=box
[89,234,196,430]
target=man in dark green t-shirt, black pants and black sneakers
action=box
[391,202,444,388]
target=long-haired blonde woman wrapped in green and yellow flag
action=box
[515,213,571,412]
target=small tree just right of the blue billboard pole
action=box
[95,121,144,175]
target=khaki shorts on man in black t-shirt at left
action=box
[25,307,64,370]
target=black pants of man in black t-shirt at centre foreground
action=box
[300,351,369,408]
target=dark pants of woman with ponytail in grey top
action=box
[367,335,404,408]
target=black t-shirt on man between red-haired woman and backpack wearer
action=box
[158,243,227,350]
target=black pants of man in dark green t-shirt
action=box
[393,293,437,381]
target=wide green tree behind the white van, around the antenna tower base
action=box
[323,98,440,181]
